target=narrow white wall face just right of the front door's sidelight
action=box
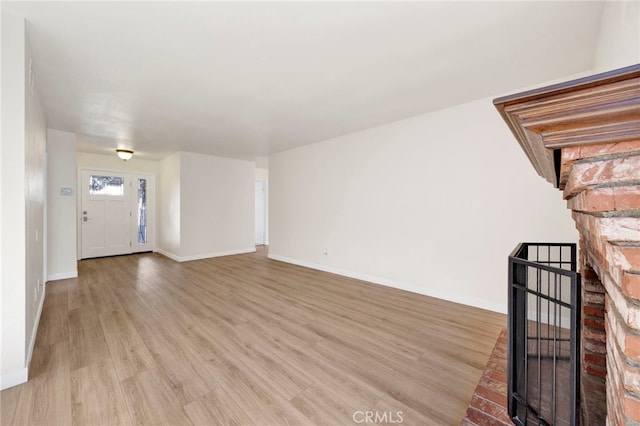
[157,152,181,257]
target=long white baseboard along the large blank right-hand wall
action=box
[268,254,507,314]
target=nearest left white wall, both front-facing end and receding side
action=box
[0,10,46,389]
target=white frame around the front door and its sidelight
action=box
[76,166,158,260]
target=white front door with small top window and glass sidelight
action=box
[80,170,155,259]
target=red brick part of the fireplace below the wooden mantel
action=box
[560,141,640,425]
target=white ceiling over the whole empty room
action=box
[2,1,603,159]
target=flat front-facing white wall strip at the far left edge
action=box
[0,10,27,389]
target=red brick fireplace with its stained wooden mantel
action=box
[494,65,640,425]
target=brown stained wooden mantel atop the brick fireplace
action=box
[493,64,640,187]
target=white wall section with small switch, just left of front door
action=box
[47,129,78,281]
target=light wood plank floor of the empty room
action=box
[1,248,506,425]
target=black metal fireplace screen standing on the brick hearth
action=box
[507,243,580,426]
